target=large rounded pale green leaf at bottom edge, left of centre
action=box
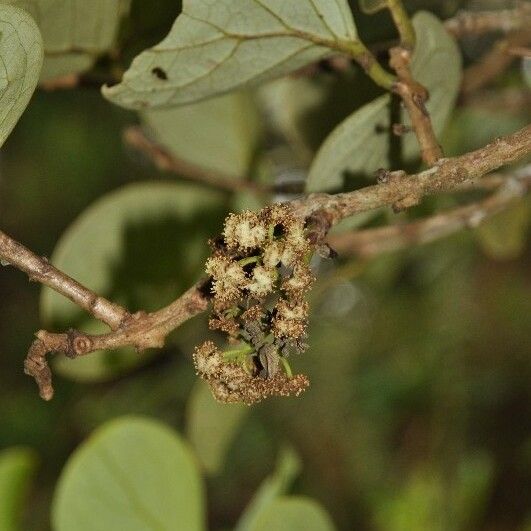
[52,417,205,531]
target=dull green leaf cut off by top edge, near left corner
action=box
[4,0,130,81]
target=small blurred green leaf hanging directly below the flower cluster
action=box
[186,381,249,474]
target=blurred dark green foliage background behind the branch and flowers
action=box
[0,0,531,531]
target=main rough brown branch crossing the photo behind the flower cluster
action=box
[0,126,531,400]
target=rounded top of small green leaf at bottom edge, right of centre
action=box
[250,496,334,531]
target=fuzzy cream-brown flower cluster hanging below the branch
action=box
[194,205,314,404]
